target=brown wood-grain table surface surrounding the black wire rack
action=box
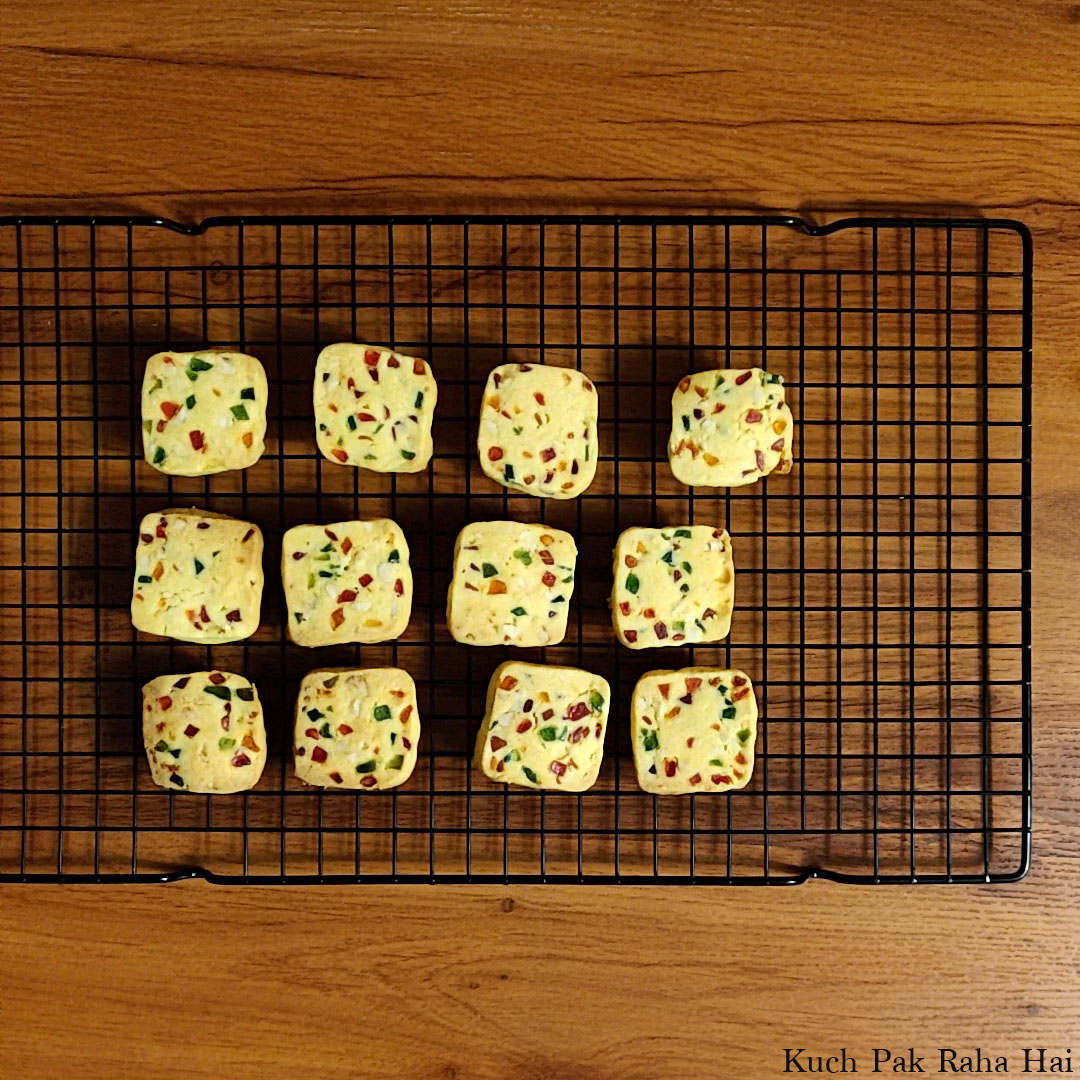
[0,0,1067,1080]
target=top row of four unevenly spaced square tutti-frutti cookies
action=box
[141,342,794,499]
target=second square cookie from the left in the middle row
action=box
[281,517,413,646]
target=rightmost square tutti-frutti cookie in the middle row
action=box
[611,525,735,649]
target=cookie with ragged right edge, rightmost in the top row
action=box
[667,367,795,487]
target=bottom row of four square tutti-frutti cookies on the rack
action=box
[143,661,757,795]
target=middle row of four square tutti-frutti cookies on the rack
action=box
[131,509,734,649]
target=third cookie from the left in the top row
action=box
[476,364,599,499]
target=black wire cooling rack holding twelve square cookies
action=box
[0,216,1031,883]
